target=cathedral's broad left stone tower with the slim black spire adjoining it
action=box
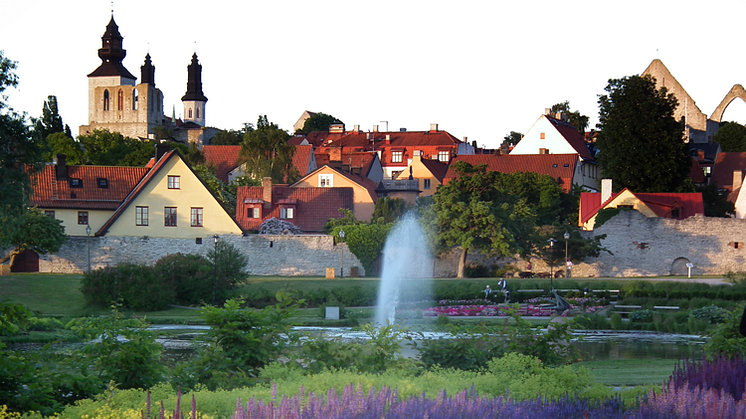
[79,15,164,138]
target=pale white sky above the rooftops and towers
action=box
[0,0,746,148]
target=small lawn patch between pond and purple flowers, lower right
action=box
[575,359,679,387]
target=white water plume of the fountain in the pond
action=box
[375,213,433,325]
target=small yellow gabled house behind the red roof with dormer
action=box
[290,165,378,221]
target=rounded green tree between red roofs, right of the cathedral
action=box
[240,115,299,183]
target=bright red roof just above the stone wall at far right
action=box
[580,188,705,224]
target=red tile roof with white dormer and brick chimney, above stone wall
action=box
[236,185,353,233]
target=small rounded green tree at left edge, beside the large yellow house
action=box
[0,209,67,266]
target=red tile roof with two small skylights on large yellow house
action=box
[30,164,148,210]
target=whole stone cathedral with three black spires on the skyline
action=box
[79,15,218,146]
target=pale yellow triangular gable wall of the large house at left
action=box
[96,151,243,239]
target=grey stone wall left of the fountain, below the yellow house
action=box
[39,235,365,276]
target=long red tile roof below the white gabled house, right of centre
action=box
[443,154,578,192]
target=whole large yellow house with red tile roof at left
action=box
[30,151,242,238]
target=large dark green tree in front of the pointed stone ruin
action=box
[596,76,691,192]
